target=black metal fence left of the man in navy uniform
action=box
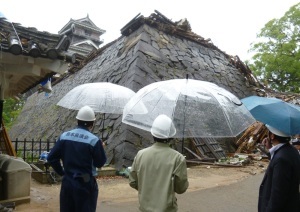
[12,139,56,163]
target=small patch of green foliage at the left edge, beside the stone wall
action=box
[2,98,25,130]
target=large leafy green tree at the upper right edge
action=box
[249,3,300,93]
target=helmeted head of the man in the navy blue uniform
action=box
[76,106,96,127]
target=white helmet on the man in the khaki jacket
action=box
[151,114,176,139]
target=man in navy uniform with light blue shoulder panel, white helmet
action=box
[47,106,106,212]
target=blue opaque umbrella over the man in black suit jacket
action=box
[241,96,300,135]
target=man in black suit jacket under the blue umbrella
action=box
[258,125,300,212]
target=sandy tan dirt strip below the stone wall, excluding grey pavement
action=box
[14,160,268,212]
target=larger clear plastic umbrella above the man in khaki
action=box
[122,79,255,138]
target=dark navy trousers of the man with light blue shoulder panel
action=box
[60,177,98,212]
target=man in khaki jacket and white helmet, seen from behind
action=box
[129,115,189,212]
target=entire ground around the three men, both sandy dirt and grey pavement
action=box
[14,161,268,212]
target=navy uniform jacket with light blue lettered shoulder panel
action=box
[47,127,106,178]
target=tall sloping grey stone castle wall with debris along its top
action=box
[9,24,255,169]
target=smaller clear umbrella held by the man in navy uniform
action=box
[57,82,135,138]
